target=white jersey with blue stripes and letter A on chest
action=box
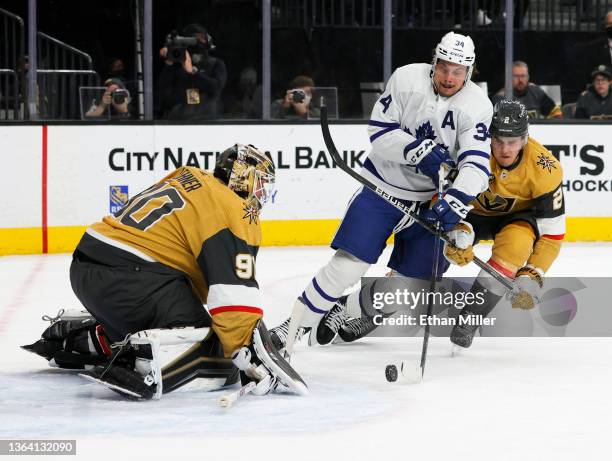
[361,64,493,200]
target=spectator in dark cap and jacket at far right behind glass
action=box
[575,64,612,119]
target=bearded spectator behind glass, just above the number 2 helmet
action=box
[491,61,562,119]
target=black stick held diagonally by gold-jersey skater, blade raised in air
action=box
[321,106,514,290]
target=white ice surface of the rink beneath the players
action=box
[0,244,612,461]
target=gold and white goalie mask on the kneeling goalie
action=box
[214,144,275,209]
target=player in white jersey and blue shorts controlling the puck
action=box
[271,32,492,346]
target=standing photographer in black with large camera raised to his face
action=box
[158,24,227,120]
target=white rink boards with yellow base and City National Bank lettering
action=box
[0,124,612,254]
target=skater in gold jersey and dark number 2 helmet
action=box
[444,100,565,347]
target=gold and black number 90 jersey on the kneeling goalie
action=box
[87,167,263,355]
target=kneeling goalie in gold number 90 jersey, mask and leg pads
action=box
[25,144,305,398]
